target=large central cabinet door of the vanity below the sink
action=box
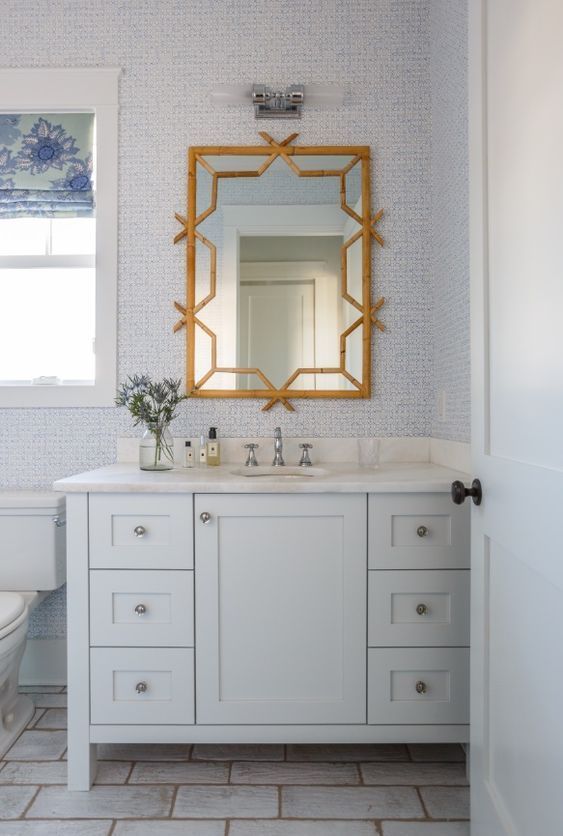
[195,494,367,724]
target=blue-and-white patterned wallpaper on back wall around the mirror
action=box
[0,0,465,636]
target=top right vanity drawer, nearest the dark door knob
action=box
[368,493,470,569]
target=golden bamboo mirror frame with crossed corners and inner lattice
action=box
[174,132,384,411]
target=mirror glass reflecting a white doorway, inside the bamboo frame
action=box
[195,155,362,390]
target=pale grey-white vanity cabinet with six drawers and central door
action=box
[60,469,469,790]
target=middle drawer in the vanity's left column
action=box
[90,569,194,647]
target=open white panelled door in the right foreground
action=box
[469,0,563,836]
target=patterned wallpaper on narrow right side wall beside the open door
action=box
[430,0,470,441]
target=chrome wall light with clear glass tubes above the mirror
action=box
[211,84,344,119]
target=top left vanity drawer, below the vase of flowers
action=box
[89,494,193,569]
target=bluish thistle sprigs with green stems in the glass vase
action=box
[115,374,188,469]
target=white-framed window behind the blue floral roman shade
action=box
[0,69,119,407]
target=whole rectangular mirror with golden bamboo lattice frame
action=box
[174,132,384,410]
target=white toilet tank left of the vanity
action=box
[0,491,66,591]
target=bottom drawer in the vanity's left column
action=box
[90,647,194,725]
